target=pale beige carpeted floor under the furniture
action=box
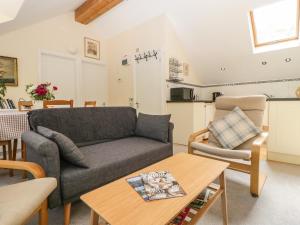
[0,146,300,225]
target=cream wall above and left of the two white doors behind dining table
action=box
[0,13,106,101]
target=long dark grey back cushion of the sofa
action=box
[29,107,137,146]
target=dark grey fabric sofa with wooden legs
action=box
[22,107,173,208]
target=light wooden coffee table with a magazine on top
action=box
[81,153,229,225]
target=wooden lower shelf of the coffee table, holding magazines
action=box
[169,184,224,225]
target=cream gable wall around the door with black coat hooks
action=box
[107,15,199,105]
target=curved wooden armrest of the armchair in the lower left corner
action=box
[0,160,45,178]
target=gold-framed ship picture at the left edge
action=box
[0,56,18,86]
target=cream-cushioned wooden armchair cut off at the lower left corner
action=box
[0,160,57,225]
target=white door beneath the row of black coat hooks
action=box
[134,51,164,114]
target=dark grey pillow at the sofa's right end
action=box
[135,113,171,143]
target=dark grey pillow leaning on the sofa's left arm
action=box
[37,126,89,168]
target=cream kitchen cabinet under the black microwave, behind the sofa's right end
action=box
[167,102,215,145]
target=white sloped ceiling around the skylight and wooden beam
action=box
[0,0,300,84]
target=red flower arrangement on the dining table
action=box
[26,83,58,101]
